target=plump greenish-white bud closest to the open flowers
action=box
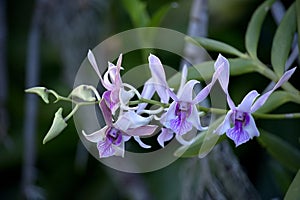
[69,85,96,101]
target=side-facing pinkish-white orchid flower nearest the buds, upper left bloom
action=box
[88,50,134,114]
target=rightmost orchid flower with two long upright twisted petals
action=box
[214,55,296,146]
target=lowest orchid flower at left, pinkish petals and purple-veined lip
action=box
[82,100,157,158]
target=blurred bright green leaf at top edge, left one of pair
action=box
[122,0,150,27]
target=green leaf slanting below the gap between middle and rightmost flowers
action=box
[174,115,225,157]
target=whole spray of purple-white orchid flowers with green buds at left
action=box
[26,51,295,158]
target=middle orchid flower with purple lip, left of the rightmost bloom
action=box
[157,55,223,146]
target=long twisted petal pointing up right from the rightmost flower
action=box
[251,67,296,113]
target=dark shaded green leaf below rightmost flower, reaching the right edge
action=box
[257,130,300,172]
